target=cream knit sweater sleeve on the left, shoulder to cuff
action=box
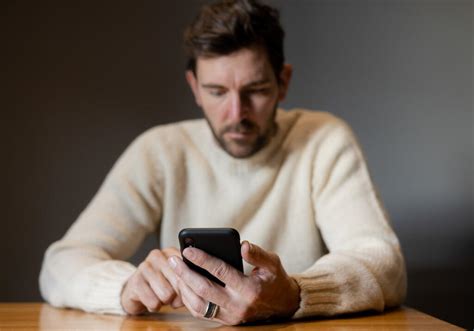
[39,130,162,314]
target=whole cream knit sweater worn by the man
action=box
[40,110,406,318]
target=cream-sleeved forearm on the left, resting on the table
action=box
[39,242,135,314]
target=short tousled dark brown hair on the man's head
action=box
[184,0,285,81]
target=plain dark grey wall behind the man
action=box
[0,0,474,327]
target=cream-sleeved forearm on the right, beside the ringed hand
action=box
[292,239,406,318]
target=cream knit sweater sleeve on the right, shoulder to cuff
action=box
[292,121,406,318]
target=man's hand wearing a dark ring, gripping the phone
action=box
[169,241,300,325]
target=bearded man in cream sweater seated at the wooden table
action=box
[40,0,406,324]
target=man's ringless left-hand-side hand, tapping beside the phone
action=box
[120,248,183,315]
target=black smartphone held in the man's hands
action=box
[178,228,244,287]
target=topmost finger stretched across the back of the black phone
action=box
[183,247,245,289]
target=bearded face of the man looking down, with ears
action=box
[186,48,291,158]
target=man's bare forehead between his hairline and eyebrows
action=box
[196,48,273,83]
